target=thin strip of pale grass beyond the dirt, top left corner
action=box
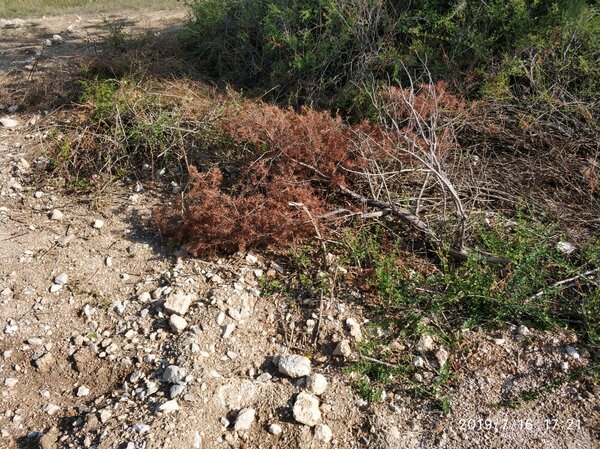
[0,0,183,19]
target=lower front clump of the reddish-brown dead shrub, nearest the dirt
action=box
[153,167,323,255]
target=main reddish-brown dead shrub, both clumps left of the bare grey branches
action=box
[154,102,359,255]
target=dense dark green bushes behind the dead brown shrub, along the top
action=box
[190,0,600,116]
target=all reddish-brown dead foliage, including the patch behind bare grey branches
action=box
[154,85,474,255]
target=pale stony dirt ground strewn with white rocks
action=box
[0,7,600,449]
